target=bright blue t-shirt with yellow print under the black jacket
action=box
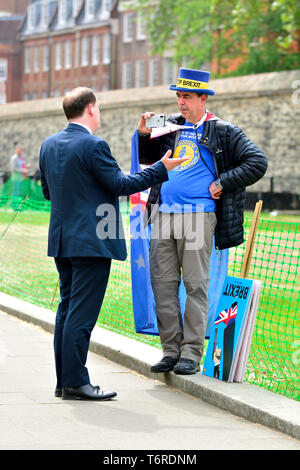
[159,122,216,213]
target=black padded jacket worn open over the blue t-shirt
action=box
[139,114,268,250]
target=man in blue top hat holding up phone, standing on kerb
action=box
[138,68,267,374]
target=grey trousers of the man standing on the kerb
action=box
[150,212,216,362]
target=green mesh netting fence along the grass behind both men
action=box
[0,180,300,401]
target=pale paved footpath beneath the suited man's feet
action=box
[0,311,300,451]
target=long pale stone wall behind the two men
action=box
[0,70,300,194]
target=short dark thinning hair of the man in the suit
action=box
[63,87,96,119]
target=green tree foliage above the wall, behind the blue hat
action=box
[137,0,300,76]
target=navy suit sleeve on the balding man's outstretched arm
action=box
[89,140,168,196]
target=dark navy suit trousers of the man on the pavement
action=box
[54,257,111,387]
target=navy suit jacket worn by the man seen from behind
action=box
[39,123,168,260]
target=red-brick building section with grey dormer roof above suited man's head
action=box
[19,0,111,99]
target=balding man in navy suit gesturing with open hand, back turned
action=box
[40,87,185,400]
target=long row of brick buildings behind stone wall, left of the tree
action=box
[12,0,176,101]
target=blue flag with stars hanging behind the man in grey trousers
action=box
[130,131,228,338]
